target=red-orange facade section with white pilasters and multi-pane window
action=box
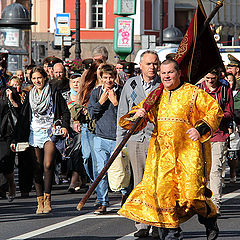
[49,0,168,62]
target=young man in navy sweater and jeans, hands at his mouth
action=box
[88,64,122,214]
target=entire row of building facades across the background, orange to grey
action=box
[0,0,240,62]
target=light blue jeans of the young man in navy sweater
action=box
[94,137,116,206]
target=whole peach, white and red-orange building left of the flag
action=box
[9,0,168,62]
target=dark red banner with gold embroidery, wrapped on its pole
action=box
[143,0,224,111]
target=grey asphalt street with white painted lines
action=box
[0,172,240,240]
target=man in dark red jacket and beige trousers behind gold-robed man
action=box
[201,69,234,215]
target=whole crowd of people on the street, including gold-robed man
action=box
[0,46,240,239]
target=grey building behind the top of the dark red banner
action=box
[168,0,240,46]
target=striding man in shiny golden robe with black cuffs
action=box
[119,60,223,239]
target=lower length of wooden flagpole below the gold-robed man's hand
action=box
[77,117,142,211]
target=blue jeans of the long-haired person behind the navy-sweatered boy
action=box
[81,123,97,182]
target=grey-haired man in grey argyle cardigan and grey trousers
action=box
[116,50,160,237]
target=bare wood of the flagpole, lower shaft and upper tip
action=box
[77,0,224,211]
